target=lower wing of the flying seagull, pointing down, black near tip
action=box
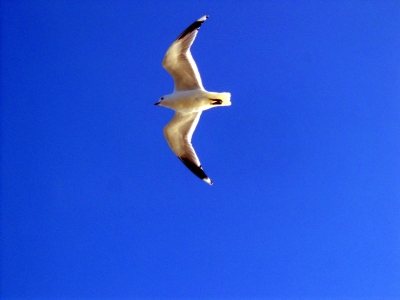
[164,111,213,185]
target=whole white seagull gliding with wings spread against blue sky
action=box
[154,15,231,185]
